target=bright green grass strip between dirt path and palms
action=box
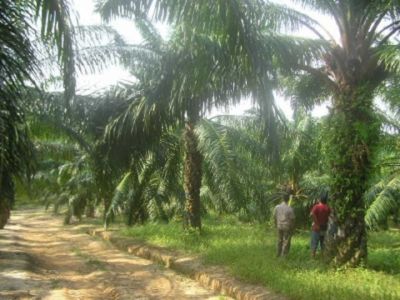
[121,217,400,300]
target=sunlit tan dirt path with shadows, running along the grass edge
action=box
[0,210,225,300]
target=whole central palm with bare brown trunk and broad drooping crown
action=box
[94,0,321,228]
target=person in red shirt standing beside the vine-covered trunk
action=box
[310,193,331,257]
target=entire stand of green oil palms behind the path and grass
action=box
[0,0,400,265]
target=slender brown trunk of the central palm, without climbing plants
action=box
[184,105,203,230]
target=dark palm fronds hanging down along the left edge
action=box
[0,0,74,227]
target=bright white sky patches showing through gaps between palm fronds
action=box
[71,0,332,119]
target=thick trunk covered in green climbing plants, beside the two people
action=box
[328,86,380,266]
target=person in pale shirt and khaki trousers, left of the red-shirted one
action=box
[274,193,295,257]
